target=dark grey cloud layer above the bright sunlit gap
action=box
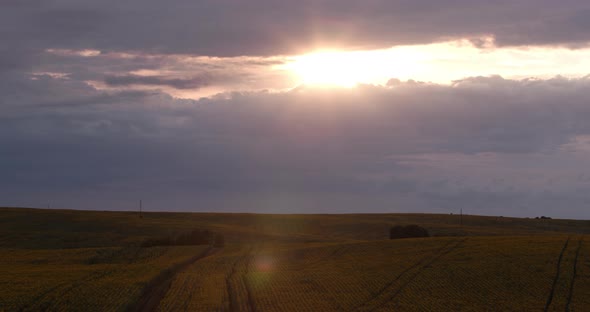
[0,0,590,56]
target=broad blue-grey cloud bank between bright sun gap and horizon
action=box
[0,76,590,218]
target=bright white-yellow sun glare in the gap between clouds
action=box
[279,37,590,88]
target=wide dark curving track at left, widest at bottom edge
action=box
[127,247,218,312]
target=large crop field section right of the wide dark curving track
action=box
[158,235,590,311]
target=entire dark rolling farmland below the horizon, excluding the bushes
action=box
[0,208,590,311]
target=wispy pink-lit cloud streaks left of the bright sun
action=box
[24,49,292,98]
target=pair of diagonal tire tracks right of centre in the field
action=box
[354,238,467,311]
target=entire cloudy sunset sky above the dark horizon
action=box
[0,0,590,219]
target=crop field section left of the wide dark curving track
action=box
[0,246,205,311]
